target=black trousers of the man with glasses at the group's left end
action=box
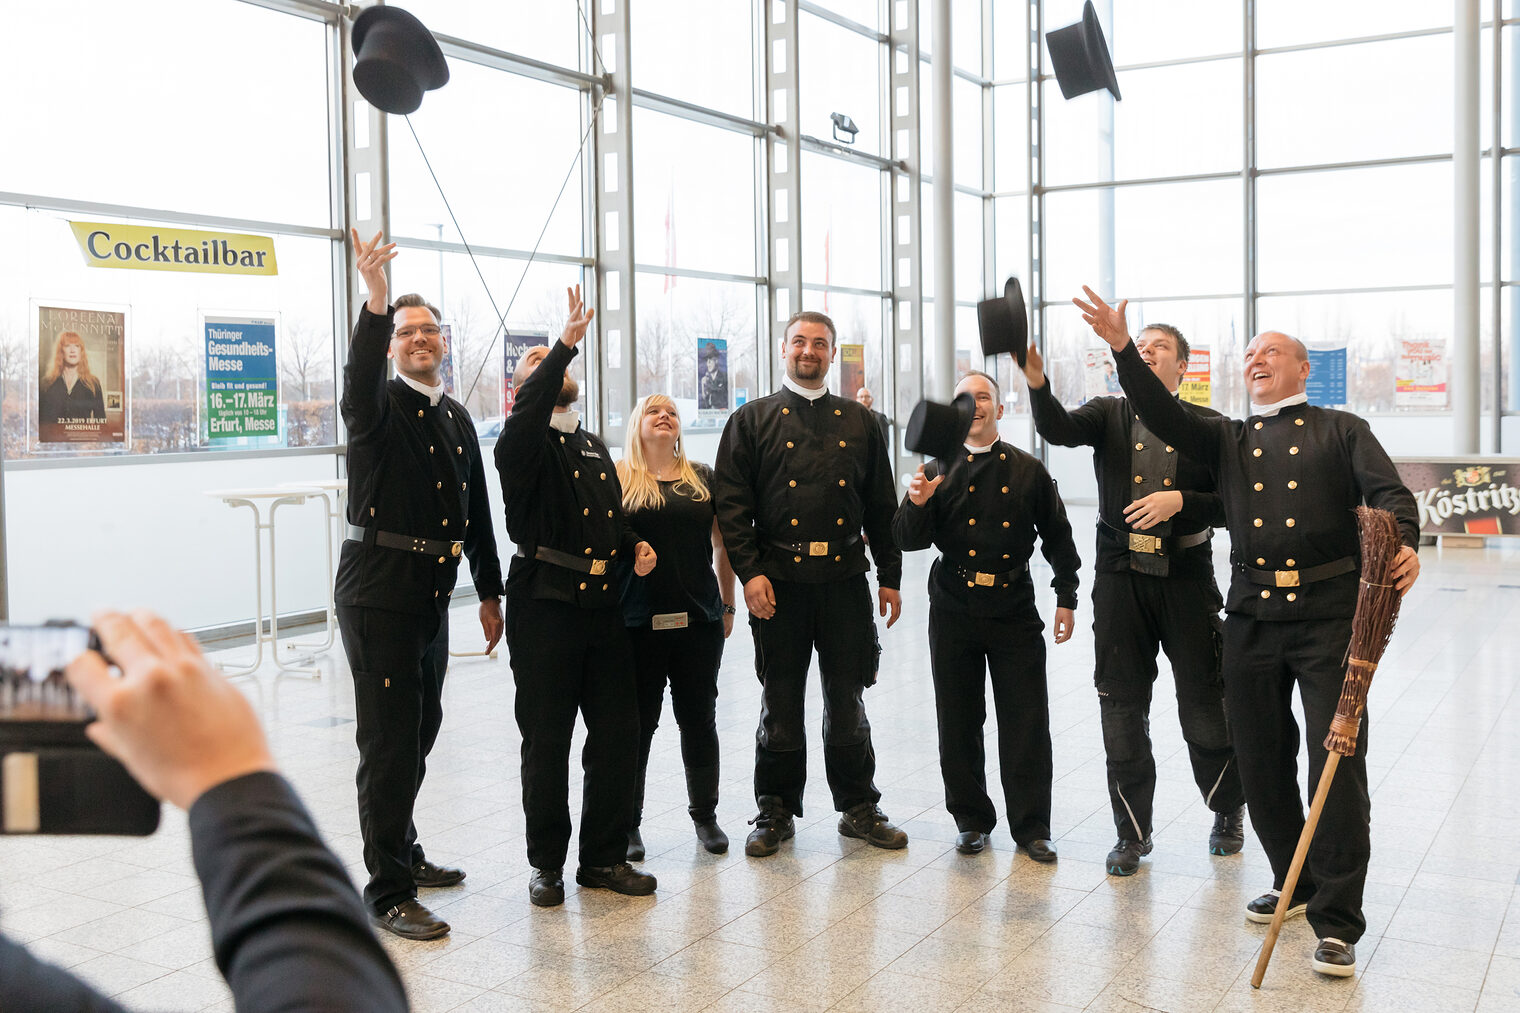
[337,599,448,913]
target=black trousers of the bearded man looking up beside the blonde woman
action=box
[506,598,638,869]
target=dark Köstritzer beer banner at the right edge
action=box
[1394,458,1520,535]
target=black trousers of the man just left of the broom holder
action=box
[1093,572,1245,841]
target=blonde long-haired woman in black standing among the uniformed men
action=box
[617,394,734,862]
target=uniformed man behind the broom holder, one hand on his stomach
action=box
[1024,324,1245,876]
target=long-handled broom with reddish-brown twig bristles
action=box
[1251,507,1403,989]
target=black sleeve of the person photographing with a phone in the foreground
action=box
[190,773,407,1013]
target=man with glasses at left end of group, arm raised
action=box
[333,230,502,938]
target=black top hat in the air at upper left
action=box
[353,8,448,116]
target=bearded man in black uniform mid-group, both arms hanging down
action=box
[714,312,907,856]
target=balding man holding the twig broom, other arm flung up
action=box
[1073,289,1420,976]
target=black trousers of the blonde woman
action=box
[628,621,724,826]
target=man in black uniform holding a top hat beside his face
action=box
[892,371,1082,862]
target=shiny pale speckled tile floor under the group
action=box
[0,507,1520,1013]
